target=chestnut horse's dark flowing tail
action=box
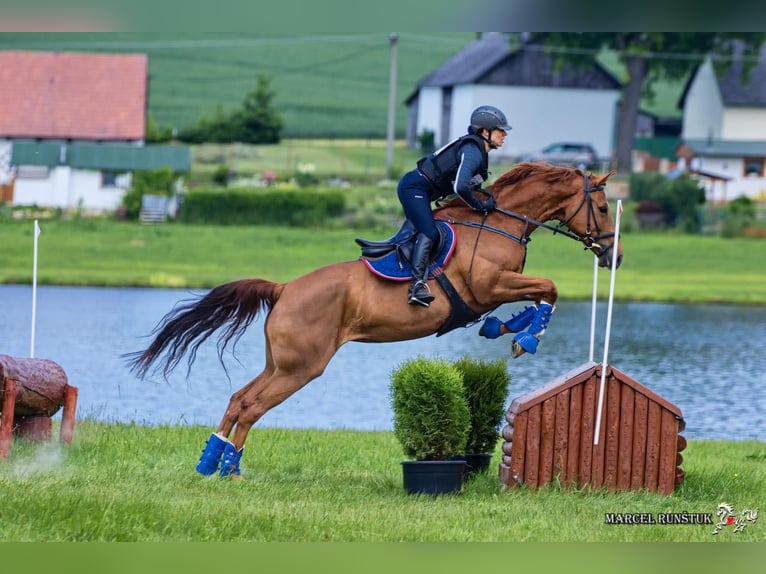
[126,279,282,378]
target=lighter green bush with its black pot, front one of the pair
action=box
[390,357,470,494]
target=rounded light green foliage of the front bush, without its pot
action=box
[390,357,470,460]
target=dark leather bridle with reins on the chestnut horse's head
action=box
[448,173,614,257]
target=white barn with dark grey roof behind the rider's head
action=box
[405,33,621,163]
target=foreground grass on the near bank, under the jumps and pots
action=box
[0,420,766,542]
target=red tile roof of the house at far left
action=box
[0,51,149,140]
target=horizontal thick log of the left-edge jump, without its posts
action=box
[0,355,68,417]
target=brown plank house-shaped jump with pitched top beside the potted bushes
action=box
[499,361,686,495]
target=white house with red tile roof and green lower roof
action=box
[0,51,191,211]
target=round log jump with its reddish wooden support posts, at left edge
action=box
[0,355,77,459]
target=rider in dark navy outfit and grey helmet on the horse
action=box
[397,106,511,307]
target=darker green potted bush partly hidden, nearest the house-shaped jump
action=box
[453,357,511,476]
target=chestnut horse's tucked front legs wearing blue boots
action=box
[479,274,558,358]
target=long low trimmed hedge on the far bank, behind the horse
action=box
[180,188,346,227]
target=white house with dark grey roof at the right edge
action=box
[676,45,766,201]
